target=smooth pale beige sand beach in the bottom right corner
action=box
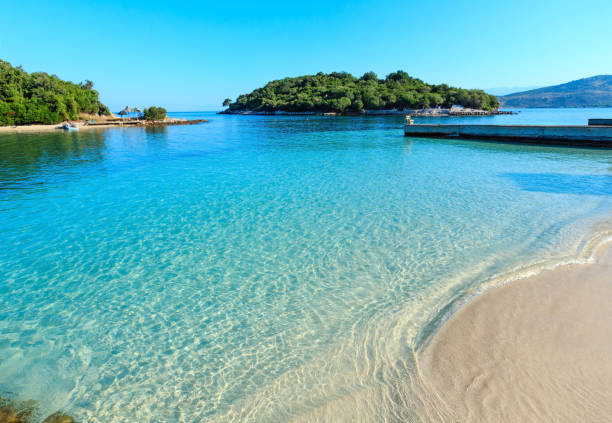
[421,240,612,422]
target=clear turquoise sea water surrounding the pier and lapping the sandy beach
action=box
[0,109,612,422]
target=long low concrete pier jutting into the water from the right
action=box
[404,124,612,148]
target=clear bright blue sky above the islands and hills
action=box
[0,0,612,110]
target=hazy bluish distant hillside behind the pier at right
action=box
[499,75,612,107]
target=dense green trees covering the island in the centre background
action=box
[224,71,499,113]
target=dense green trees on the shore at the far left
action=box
[0,60,110,126]
